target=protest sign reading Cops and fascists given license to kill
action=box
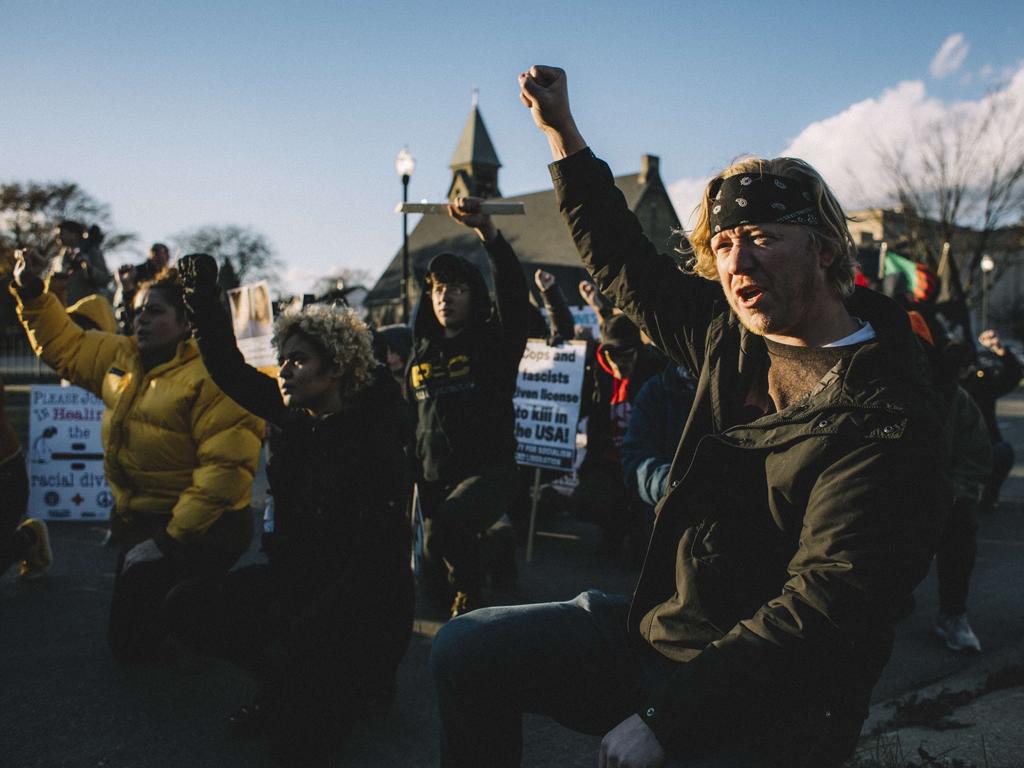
[513,339,587,470]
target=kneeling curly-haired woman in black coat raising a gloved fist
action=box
[178,255,414,766]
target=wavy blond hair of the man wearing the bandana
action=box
[679,158,857,299]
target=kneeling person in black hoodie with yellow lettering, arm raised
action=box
[409,198,529,615]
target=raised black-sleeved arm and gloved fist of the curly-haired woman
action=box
[178,254,287,426]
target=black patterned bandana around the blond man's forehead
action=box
[709,173,821,234]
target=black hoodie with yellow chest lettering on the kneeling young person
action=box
[408,233,529,484]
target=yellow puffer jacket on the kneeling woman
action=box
[15,293,263,543]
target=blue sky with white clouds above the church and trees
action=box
[0,0,1024,290]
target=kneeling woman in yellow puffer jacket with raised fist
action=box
[12,253,263,660]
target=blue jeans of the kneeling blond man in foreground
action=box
[430,590,763,768]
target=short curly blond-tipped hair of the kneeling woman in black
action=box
[272,304,377,399]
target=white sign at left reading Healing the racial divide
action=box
[28,384,114,520]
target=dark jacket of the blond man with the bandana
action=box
[551,150,948,766]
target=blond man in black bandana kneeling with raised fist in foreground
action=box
[431,67,949,768]
